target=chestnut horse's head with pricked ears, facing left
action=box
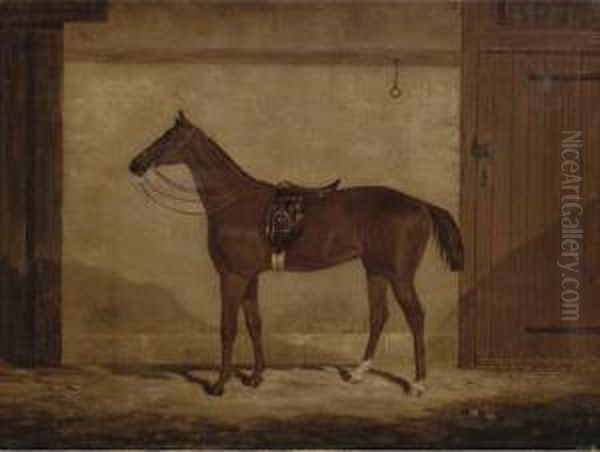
[129,110,199,176]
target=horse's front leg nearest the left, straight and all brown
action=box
[210,274,250,395]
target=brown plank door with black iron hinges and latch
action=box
[464,51,600,364]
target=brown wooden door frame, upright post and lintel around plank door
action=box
[458,0,600,368]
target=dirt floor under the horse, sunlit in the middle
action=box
[0,360,600,448]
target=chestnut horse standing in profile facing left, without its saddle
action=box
[129,112,463,395]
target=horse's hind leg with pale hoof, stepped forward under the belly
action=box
[350,274,389,383]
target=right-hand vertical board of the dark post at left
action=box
[27,30,63,366]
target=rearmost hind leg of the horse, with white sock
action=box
[390,277,426,395]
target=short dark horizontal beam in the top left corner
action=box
[0,0,108,28]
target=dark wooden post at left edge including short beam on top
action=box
[0,1,106,366]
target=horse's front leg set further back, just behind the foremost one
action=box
[242,277,265,388]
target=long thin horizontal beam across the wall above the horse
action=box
[65,48,460,66]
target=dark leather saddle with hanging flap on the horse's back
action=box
[265,179,340,255]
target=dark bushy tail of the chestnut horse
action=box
[428,205,464,272]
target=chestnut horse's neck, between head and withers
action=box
[188,134,268,211]
